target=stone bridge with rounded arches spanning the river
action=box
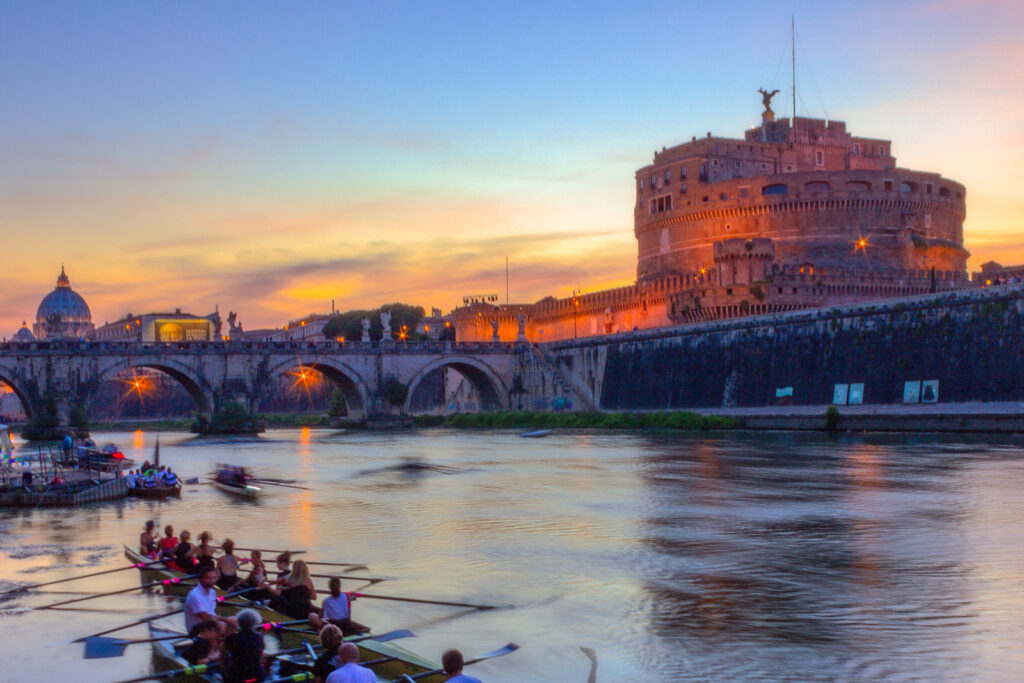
[0,340,577,426]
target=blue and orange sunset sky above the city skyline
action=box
[0,0,1024,337]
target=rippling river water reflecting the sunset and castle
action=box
[0,430,1024,682]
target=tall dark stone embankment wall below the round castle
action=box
[543,286,1024,416]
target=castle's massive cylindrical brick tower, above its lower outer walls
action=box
[634,119,969,282]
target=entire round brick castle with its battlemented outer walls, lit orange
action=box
[452,97,970,342]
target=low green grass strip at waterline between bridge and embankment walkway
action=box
[414,411,743,430]
